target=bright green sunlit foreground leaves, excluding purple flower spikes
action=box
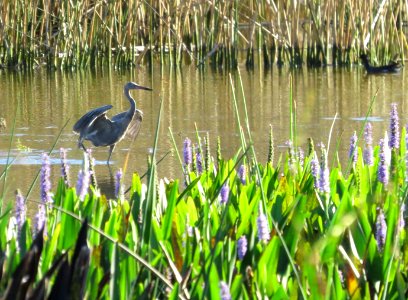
[0,127,407,299]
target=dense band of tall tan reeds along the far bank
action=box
[0,0,407,68]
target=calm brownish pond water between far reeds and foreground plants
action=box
[0,66,407,206]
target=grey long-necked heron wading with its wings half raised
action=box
[73,82,152,165]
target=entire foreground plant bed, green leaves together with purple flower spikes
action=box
[0,77,408,299]
